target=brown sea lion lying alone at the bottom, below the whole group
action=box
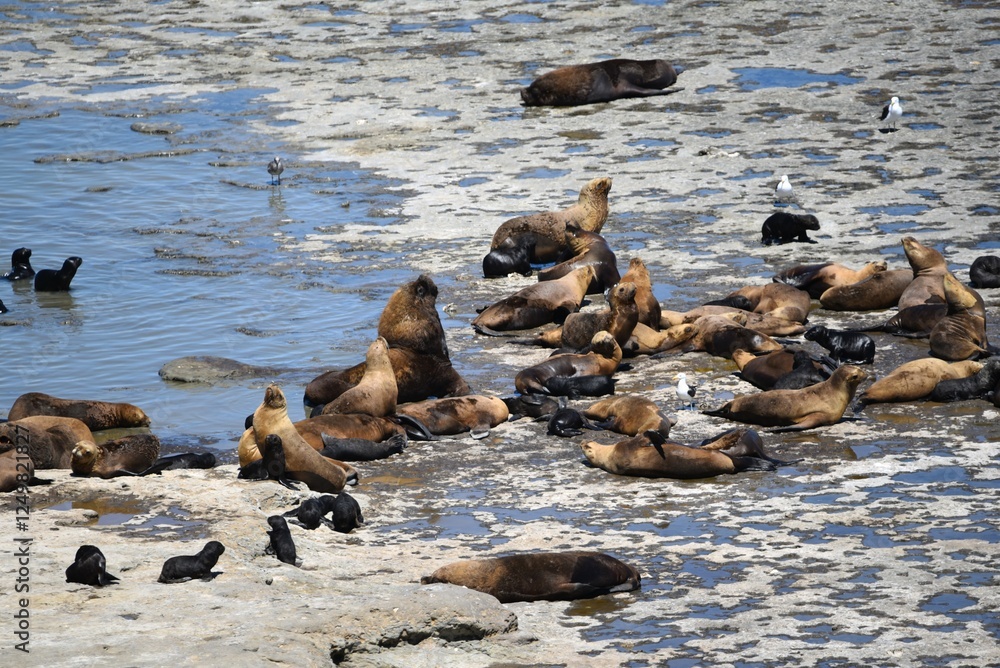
[420,552,639,603]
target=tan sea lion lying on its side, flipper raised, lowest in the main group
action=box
[580,429,777,480]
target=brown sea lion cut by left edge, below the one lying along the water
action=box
[0,415,94,469]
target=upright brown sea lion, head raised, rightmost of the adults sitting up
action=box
[930,272,990,362]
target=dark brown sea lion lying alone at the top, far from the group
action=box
[521,58,683,107]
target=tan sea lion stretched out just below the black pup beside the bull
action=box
[472,265,595,331]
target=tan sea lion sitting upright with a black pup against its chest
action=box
[252,384,357,492]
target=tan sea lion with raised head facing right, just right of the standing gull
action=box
[702,364,867,431]
